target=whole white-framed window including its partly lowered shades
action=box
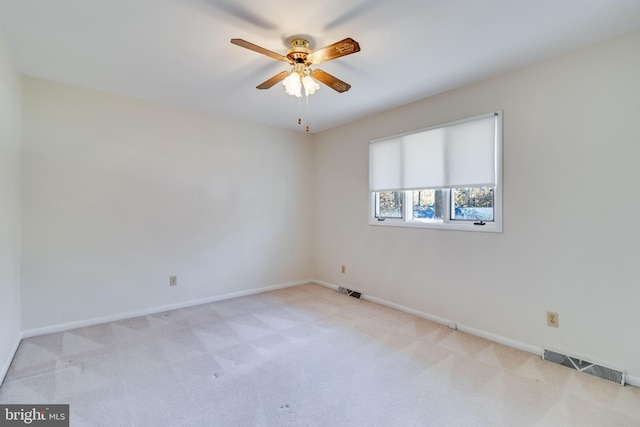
[369,111,502,232]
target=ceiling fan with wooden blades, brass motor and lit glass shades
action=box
[231,37,360,97]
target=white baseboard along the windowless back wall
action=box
[22,280,312,338]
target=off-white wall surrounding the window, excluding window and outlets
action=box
[315,33,640,377]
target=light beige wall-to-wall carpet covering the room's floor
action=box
[0,285,640,427]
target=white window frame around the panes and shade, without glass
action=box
[369,110,503,233]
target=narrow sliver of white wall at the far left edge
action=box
[0,32,21,382]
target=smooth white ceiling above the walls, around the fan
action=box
[0,0,640,132]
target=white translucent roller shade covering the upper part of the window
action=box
[369,113,499,191]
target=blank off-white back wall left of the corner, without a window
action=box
[22,77,313,330]
